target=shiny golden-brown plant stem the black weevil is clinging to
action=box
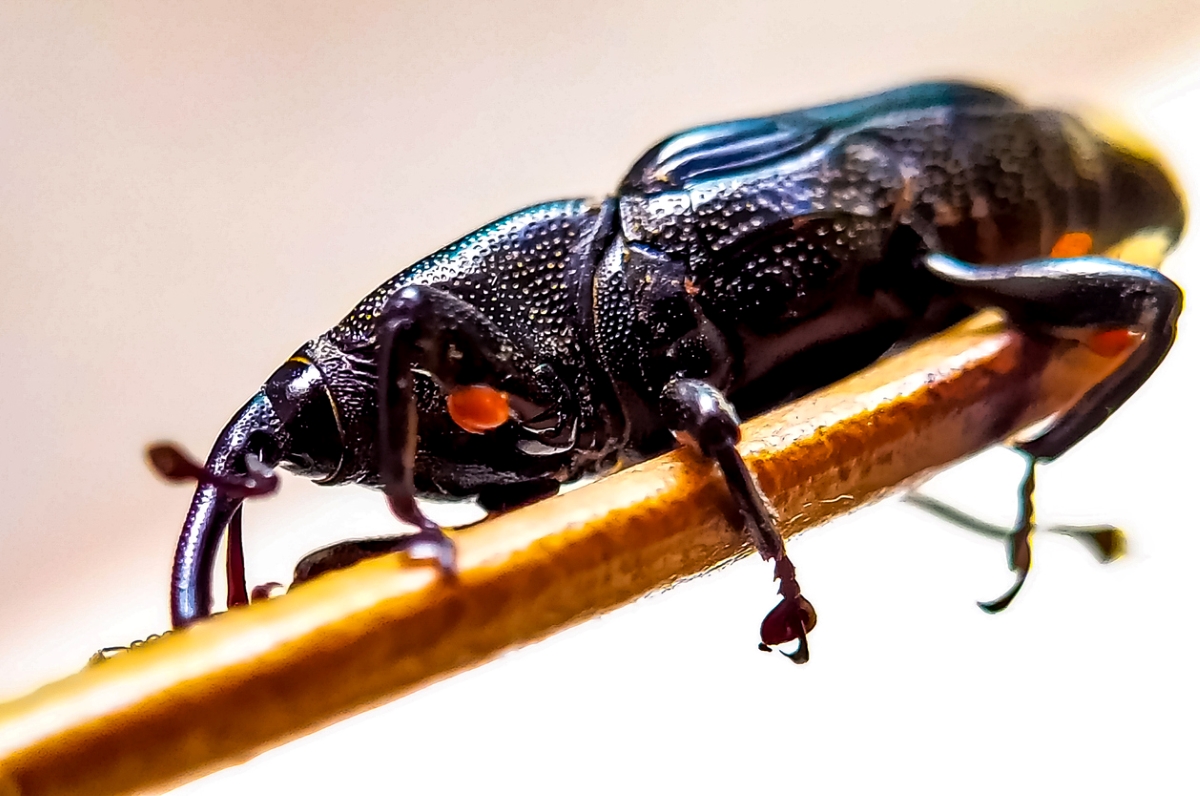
[0,313,1118,796]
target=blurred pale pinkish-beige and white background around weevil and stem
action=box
[0,0,1200,796]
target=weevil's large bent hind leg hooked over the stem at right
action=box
[925,255,1183,612]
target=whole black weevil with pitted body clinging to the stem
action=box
[152,83,1184,662]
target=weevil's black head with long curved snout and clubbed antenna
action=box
[162,357,341,628]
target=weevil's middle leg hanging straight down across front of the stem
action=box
[662,378,817,663]
